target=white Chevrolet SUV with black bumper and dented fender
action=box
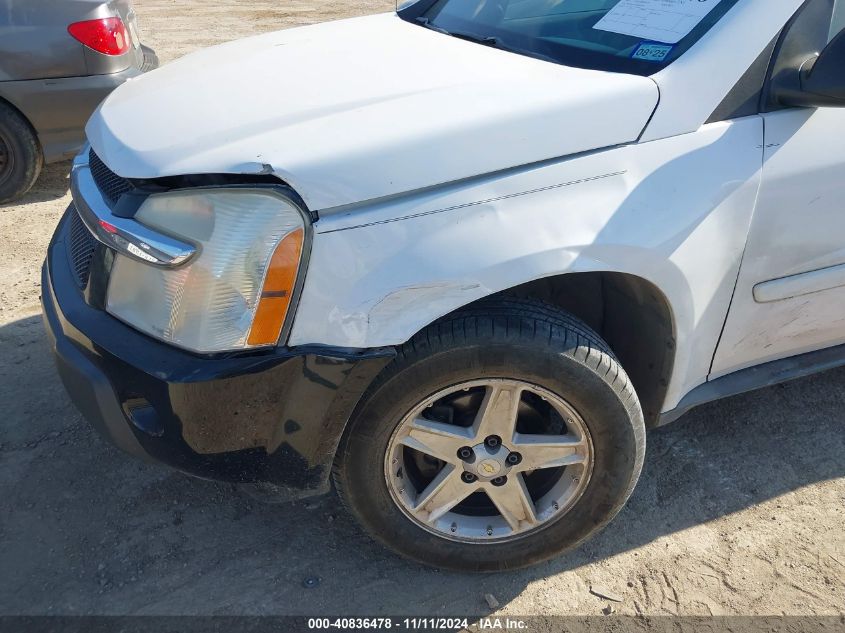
[43,0,845,570]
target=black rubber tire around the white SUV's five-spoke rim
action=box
[333,298,645,572]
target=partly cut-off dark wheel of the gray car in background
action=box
[0,102,44,204]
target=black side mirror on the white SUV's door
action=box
[777,30,845,107]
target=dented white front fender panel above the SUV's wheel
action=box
[290,117,763,409]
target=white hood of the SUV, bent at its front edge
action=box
[86,14,658,210]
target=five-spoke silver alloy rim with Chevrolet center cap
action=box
[384,379,593,542]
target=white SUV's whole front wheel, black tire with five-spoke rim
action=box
[334,299,645,571]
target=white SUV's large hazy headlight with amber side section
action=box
[107,189,305,352]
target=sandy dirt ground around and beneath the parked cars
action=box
[0,0,845,615]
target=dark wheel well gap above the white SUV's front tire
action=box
[474,272,675,426]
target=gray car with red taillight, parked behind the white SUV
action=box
[0,0,158,203]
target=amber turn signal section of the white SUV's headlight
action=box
[248,229,305,345]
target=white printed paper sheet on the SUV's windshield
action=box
[593,0,720,44]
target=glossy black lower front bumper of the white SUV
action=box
[42,210,393,496]
